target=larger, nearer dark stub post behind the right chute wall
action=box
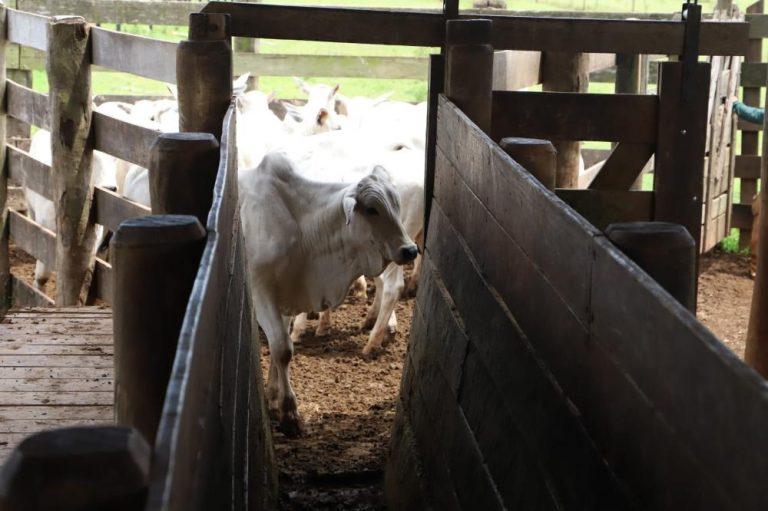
[605,222,697,313]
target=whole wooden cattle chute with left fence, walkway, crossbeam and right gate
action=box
[0,1,768,510]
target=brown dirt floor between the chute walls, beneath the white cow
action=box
[261,281,415,510]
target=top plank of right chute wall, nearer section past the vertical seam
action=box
[592,240,768,509]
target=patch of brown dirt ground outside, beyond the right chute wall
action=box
[698,250,754,359]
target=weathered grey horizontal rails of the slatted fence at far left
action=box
[0,9,158,307]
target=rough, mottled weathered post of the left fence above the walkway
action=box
[46,16,96,307]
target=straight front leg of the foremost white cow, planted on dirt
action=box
[254,295,304,438]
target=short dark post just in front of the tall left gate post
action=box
[149,133,219,225]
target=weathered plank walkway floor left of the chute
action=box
[0,307,113,462]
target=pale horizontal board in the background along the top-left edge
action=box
[17,0,205,26]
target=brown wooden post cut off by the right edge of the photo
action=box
[744,85,768,378]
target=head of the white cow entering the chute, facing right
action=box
[344,166,418,270]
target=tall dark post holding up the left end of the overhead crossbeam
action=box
[176,13,232,140]
